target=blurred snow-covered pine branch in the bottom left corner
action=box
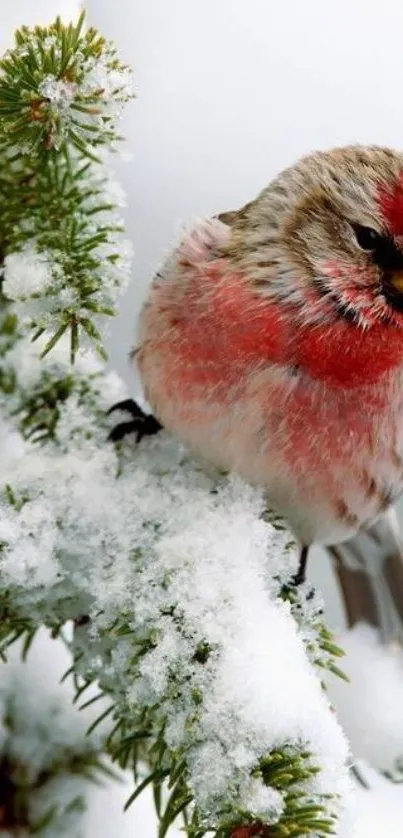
[0,638,109,838]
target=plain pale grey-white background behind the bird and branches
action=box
[0,0,403,838]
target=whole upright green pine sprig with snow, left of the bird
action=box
[0,16,133,360]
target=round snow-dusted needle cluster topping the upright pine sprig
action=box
[0,13,133,154]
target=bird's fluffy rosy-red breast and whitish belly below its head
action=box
[137,220,403,543]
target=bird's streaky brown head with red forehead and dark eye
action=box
[224,146,403,328]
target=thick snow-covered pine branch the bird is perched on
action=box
[0,348,348,834]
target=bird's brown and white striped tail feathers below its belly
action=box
[328,510,403,643]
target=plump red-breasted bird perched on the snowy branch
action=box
[111,145,403,641]
